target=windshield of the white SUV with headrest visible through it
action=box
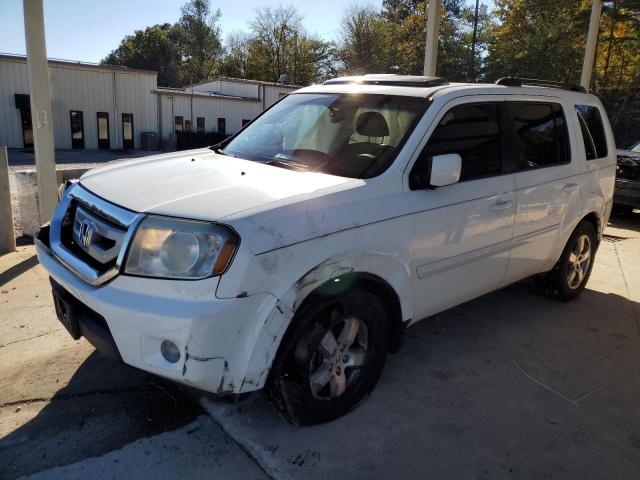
[224,93,428,178]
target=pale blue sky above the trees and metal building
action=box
[0,0,382,62]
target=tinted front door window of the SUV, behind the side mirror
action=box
[419,103,502,181]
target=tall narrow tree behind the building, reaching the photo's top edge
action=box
[175,0,223,84]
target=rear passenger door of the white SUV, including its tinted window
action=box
[506,97,582,282]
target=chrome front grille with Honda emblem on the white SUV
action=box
[50,184,143,285]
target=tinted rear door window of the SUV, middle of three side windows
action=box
[509,102,570,170]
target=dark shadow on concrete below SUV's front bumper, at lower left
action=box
[0,352,202,479]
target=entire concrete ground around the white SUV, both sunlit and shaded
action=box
[0,214,640,479]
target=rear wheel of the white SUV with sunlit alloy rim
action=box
[536,220,597,301]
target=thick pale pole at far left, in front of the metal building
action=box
[22,0,58,224]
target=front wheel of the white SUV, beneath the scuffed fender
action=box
[269,288,389,425]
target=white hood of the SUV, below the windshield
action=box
[80,149,354,221]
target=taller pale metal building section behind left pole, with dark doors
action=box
[0,55,158,149]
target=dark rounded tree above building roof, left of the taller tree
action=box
[101,23,182,87]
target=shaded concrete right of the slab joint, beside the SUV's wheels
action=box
[206,281,640,479]
